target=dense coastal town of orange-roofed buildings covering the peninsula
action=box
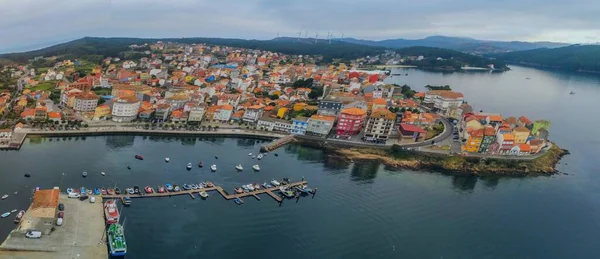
[0,41,550,157]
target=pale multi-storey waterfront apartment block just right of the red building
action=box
[365,108,396,141]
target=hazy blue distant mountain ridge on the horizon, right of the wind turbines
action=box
[336,36,569,54]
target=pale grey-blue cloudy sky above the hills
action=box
[0,0,600,52]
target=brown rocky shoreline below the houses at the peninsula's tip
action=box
[324,145,568,176]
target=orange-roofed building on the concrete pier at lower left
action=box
[25,187,60,235]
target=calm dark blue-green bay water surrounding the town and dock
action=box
[0,67,600,258]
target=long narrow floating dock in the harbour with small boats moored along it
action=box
[101,181,307,202]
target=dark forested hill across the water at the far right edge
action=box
[495,45,600,72]
